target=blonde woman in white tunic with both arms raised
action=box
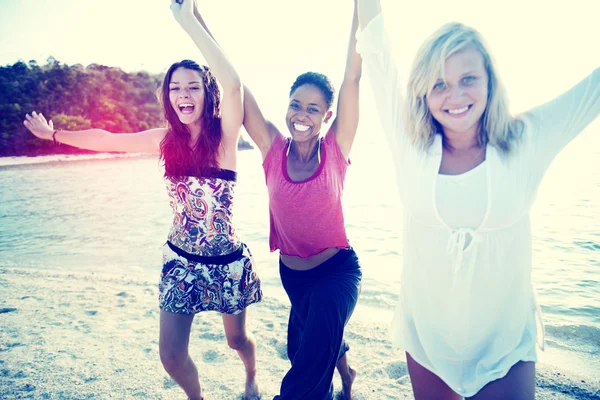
[357,0,600,400]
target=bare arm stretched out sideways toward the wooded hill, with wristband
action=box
[23,111,167,153]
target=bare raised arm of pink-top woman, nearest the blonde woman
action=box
[332,0,362,158]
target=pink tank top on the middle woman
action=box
[263,130,349,258]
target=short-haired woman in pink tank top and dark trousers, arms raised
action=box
[193,1,362,400]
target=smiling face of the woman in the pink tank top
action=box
[286,84,331,142]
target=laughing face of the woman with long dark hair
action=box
[169,67,204,125]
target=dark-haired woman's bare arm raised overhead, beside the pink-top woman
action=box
[171,0,244,148]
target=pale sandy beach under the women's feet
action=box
[0,267,600,400]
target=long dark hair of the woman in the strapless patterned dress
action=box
[159,60,222,176]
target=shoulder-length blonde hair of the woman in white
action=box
[405,22,521,154]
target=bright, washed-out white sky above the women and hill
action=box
[0,0,600,123]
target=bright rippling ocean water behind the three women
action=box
[0,132,600,381]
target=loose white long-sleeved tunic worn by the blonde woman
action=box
[357,7,600,397]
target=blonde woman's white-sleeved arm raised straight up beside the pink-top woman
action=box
[357,0,406,159]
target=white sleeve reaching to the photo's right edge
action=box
[523,68,600,175]
